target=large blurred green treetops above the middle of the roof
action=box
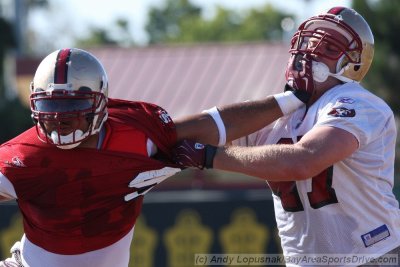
[146,0,290,44]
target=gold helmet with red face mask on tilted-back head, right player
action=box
[286,7,374,95]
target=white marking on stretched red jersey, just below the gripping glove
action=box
[125,167,181,201]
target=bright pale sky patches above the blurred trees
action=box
[29,0,351,48]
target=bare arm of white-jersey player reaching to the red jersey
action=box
[213,126,358,181]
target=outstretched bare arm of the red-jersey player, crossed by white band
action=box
[174,96,283,145]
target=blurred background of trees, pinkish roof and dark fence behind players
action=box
[0,0,400,267]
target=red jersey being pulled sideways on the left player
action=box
[0,99,176,255]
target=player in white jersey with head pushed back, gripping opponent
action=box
[175,7,400,266]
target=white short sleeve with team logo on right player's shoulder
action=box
[315,96,391,149]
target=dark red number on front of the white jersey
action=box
[268,138,338,212]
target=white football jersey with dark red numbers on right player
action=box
[234,83,400,266]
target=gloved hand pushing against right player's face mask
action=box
[285,53,315,104]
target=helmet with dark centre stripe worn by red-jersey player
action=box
[30,48,108,149]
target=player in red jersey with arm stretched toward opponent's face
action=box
[0,48,304,267]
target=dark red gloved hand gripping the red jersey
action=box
[172,139,217,170]
